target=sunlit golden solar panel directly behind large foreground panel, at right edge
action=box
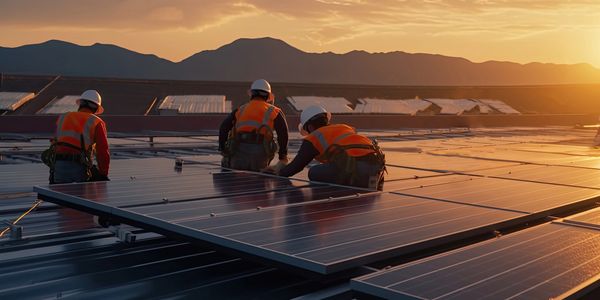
[401,178,600,213]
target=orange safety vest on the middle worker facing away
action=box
[235,100,281,138]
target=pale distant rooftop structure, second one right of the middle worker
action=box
[354,98,431,116]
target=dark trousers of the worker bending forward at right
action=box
[308,161,383,190]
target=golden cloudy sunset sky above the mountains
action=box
[0,0,600,68]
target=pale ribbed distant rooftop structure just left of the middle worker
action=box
[158,95,232,115]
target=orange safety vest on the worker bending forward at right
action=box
[304,124,375,163]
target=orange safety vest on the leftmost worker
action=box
[56,112,103,151]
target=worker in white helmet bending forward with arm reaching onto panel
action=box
[268,106,385,190]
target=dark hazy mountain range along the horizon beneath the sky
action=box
[0,38,600,86]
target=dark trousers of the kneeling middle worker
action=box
[229,143,273,172]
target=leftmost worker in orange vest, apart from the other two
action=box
[43,90,110,183]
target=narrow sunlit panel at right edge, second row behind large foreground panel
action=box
[473,165,600,189]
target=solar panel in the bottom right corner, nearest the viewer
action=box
[351,224,600,299]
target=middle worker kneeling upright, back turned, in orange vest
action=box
[219,79,288,171]
